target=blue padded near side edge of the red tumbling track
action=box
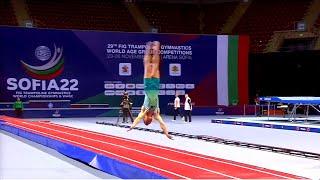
[0,123,166,179]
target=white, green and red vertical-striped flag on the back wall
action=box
[217,35,249,106]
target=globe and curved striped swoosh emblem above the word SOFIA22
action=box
[21,44,64,80]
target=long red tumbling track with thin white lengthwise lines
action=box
[0,116,303,179]
